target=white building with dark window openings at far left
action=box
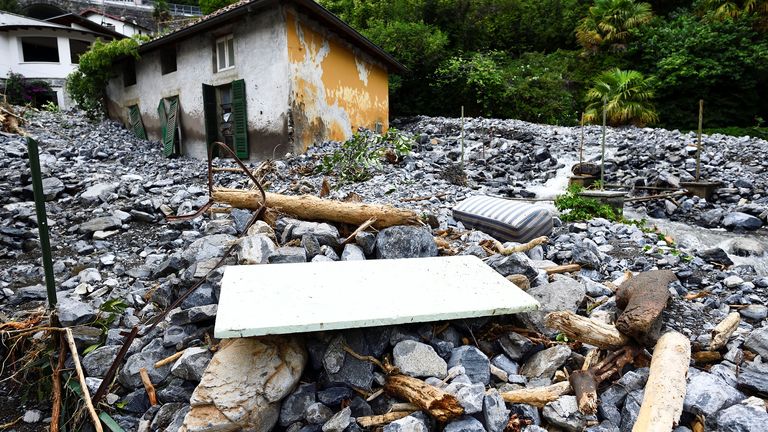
[0,12,120,108]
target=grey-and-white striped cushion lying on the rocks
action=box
[453,195,552,242]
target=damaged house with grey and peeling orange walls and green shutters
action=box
[107,0,403,158]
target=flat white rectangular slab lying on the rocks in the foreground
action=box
[214,256,539,338]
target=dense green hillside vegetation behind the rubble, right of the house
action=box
[320,0,768,129]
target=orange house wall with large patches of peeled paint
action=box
[285,9,389,149]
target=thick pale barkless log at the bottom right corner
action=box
[632,332,691,432]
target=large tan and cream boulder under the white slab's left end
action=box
[180,337,307,432]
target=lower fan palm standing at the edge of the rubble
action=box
[584,68,658,126]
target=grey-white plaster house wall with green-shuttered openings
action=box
[107,9,293,159]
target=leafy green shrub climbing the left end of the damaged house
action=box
[67,38,139,118]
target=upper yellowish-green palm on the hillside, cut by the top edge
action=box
[576,0,653,52]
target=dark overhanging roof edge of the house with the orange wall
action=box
[139,0,407,72]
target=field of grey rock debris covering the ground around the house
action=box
[0,112,768,432]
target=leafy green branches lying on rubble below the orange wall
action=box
[317,128,413,185]
